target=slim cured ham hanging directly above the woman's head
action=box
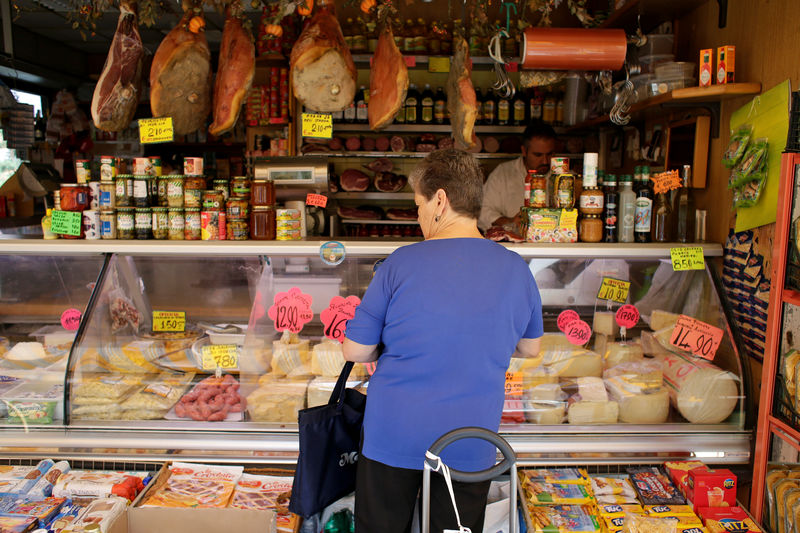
[447,37,478,149]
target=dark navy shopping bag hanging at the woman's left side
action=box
[289,362,367,517]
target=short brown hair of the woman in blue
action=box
[408,148,483,220]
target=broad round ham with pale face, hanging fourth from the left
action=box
[290,0,357,113]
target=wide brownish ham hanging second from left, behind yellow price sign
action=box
[150,4,211,135]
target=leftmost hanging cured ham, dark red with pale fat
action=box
[92,1,144,131]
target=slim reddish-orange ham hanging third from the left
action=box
[208,13,256,136]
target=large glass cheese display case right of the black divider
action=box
[0,241,749,464]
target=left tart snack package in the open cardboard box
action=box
[142,462,244,508]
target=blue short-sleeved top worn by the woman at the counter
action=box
[346,238,543,471]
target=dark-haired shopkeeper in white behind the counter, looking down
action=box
[478,121,556,231]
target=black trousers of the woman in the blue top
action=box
[355,455,491,533]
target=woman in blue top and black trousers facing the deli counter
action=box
[344,149,543,533]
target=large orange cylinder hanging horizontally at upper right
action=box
[522,28,628,70]
